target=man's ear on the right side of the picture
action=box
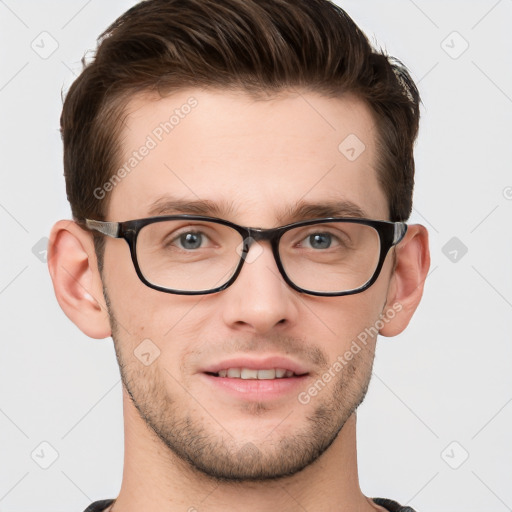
[379,224,430,336]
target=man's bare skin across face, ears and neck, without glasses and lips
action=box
[49,89,429,512]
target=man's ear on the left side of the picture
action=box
[48,220,111,339]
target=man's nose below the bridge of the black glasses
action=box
[222,241,299,334]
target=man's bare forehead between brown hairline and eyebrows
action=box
[108,89,388,226]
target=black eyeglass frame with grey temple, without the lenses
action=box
[81,214,407,297]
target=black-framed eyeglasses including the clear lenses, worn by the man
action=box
[85,215,407,297]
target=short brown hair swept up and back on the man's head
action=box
[61,0,420,226]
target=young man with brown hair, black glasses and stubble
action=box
[49,0,429,512]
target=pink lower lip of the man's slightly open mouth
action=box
[202,373,308,400]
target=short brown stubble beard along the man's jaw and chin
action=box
[104,291,373,483]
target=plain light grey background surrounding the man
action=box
[0,0,512,512]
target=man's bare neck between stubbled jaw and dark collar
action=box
[112,392,383,512]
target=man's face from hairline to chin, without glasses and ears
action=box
[103,90,392,480]
